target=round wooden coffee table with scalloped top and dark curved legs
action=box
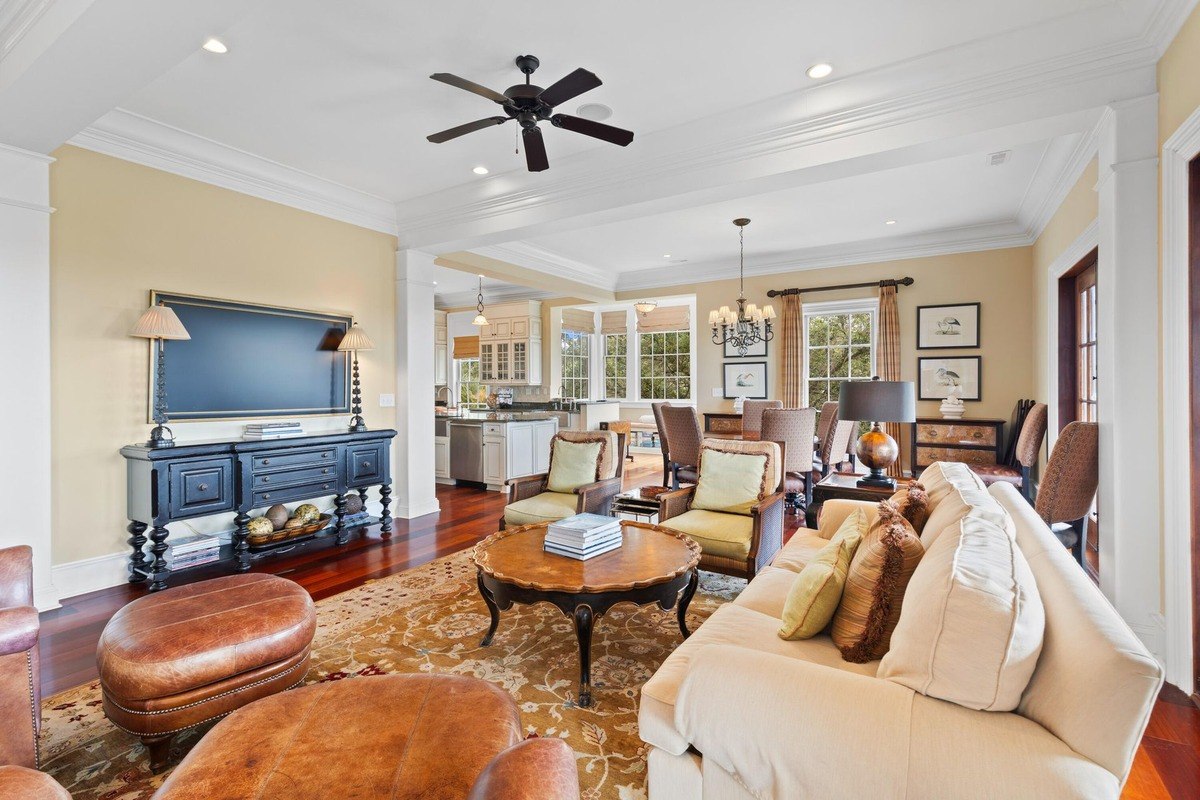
[472,521,700,708]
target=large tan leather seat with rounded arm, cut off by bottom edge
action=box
[155,674,578,800]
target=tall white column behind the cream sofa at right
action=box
[1097,95,1164,660]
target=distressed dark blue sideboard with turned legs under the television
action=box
[121,429,396,591]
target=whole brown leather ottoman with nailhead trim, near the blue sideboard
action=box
[96,575,317,770]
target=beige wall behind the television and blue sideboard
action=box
[50,146,396,566]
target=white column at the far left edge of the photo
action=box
[0,145,59,610]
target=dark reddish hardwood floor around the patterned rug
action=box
[38,455,1200,800]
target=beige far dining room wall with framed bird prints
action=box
[618,247,1033,450]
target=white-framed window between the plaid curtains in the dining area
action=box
[804,300,878,409]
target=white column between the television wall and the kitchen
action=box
[392,249,440,519]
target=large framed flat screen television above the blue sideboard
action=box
[148,291,353,422]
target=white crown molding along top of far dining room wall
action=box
[617,221,1033,291]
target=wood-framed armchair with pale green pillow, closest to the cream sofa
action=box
[659,439,786,579]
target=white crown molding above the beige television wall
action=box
[68,108,397,235]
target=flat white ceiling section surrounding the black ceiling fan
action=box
[122,0,1118,200]
